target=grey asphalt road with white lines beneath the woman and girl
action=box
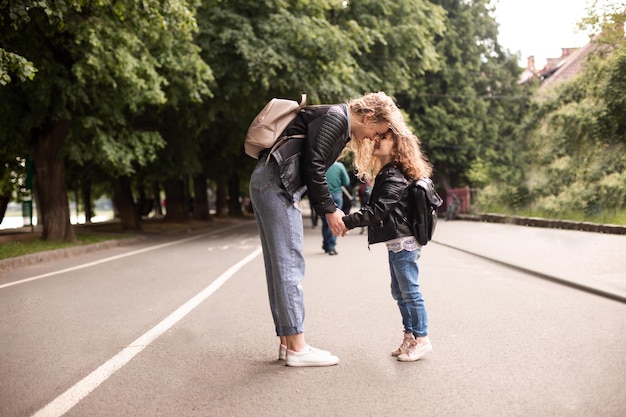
[0,221,626,417]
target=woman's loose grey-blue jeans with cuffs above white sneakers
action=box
[250,158,304,336]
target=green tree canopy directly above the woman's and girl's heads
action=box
[197,0,443,210]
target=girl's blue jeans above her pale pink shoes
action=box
[389,249,428,337]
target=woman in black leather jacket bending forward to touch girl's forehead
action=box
[250,92,401,366]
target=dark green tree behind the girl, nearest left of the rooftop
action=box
[400,0,527,193]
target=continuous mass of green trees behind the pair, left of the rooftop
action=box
[0,0,540,239]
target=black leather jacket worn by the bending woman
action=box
[271,104,350,215]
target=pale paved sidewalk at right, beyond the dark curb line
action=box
[433,220,626,303]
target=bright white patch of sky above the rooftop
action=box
[492,0,589,68]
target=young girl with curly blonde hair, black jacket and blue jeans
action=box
[343,123,432,362]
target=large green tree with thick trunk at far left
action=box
[0,0,211,241]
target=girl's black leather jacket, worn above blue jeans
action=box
[343,164,413,244]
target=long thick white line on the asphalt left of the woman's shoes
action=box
[32,245,261,417]
